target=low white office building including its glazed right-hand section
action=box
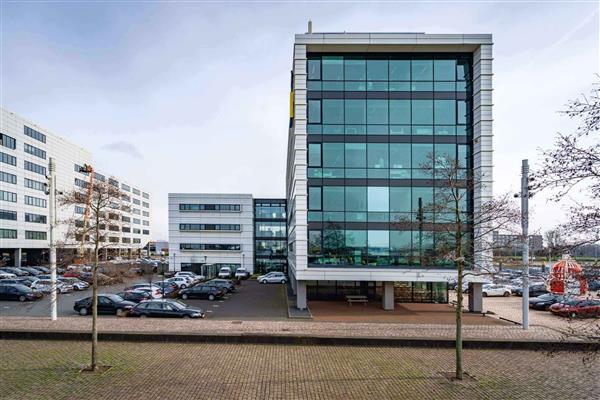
[169,193,287,276]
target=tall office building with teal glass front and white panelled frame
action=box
[286,32,492,311]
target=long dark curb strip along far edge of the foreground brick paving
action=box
[0,330,600,351]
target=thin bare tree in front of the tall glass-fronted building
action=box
[404,153,520,379]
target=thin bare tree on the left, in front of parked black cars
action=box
[60,181,123,371]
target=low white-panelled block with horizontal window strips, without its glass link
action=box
[169,193,254,275]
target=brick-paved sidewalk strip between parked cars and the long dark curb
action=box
[0,317,578,341]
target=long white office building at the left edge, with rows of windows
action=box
[0,109,151,265]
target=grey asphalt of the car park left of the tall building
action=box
[0,276,287,320]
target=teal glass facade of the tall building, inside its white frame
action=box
[307,53,473,268]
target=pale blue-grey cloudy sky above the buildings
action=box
[0,1,599,239]
